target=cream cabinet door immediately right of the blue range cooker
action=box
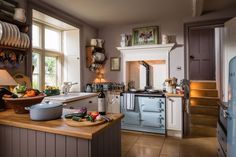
[166,97,182,131]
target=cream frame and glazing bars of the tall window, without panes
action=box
[32,20,64,90]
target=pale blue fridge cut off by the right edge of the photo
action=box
[227,57,236,157]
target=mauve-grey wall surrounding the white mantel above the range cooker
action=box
[99,19,184,82]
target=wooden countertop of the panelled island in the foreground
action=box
[0,109,124,139]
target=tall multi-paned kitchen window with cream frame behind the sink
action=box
[32,22,63,90]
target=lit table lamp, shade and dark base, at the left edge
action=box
[0,69,17,111]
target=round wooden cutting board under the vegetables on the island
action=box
[64,118,106,127]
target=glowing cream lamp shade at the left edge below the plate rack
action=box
[0,69,17,86]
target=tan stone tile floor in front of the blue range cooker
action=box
[121,132,217,157]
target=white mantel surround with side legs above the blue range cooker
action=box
[117,43,175,88]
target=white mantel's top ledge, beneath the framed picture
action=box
[117,43,175,52]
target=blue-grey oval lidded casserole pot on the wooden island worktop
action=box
[25,102,63,121]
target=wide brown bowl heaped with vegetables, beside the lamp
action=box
[3,95,44,114]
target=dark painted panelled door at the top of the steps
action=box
[189,28,215,80]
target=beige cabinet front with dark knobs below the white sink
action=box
[64,96,98,111]
